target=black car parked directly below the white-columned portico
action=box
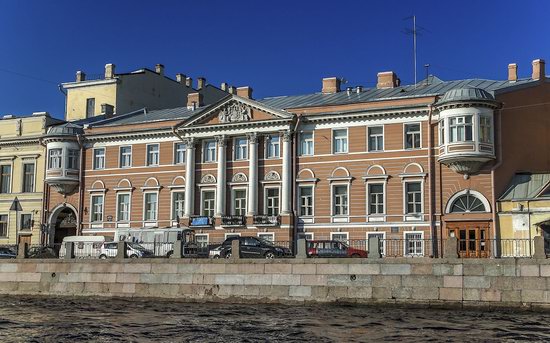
[220,237,292,258]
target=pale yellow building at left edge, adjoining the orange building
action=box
[0,112,61,245]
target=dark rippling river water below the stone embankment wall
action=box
[0,297,550,343]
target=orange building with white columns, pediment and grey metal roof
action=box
[46,60,550,257]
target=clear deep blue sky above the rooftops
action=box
[0,0,550,117]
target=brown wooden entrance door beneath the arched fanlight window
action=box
[448,222,491,257]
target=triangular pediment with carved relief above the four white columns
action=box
[182,95,293,127]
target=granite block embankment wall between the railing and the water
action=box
[0,258,550,309]
